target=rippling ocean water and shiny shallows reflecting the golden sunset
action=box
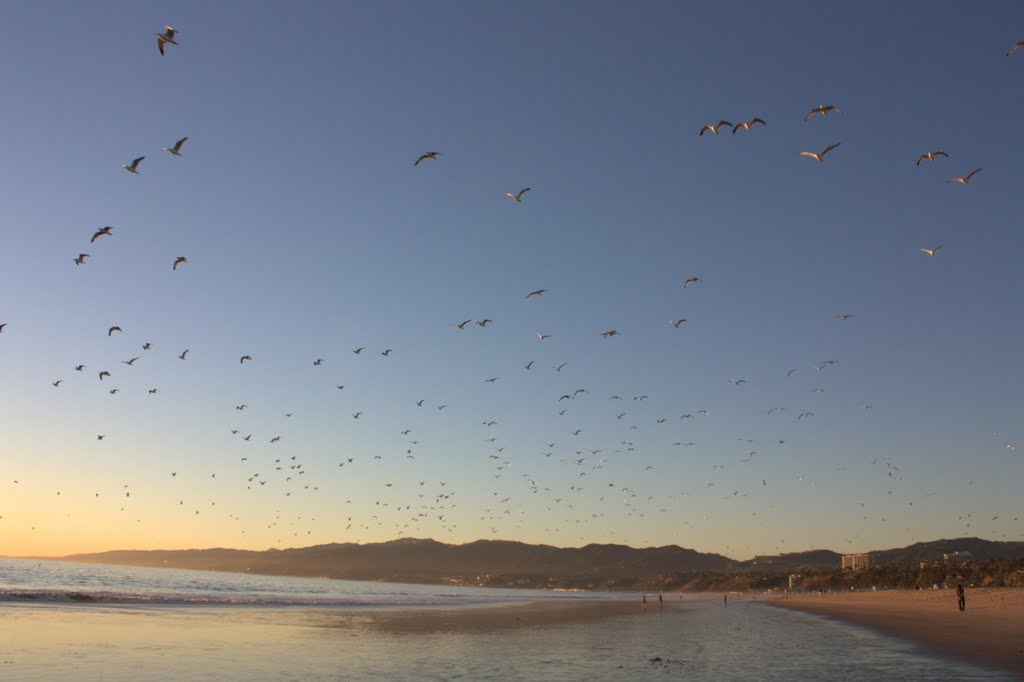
[0,559,1016,680]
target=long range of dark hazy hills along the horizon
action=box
[65,538,1024,589]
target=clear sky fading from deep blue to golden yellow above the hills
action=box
[0,2,1024,559]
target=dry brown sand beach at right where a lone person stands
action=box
[772,589,1024,677]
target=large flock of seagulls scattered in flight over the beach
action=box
[0,26,1024,557]
